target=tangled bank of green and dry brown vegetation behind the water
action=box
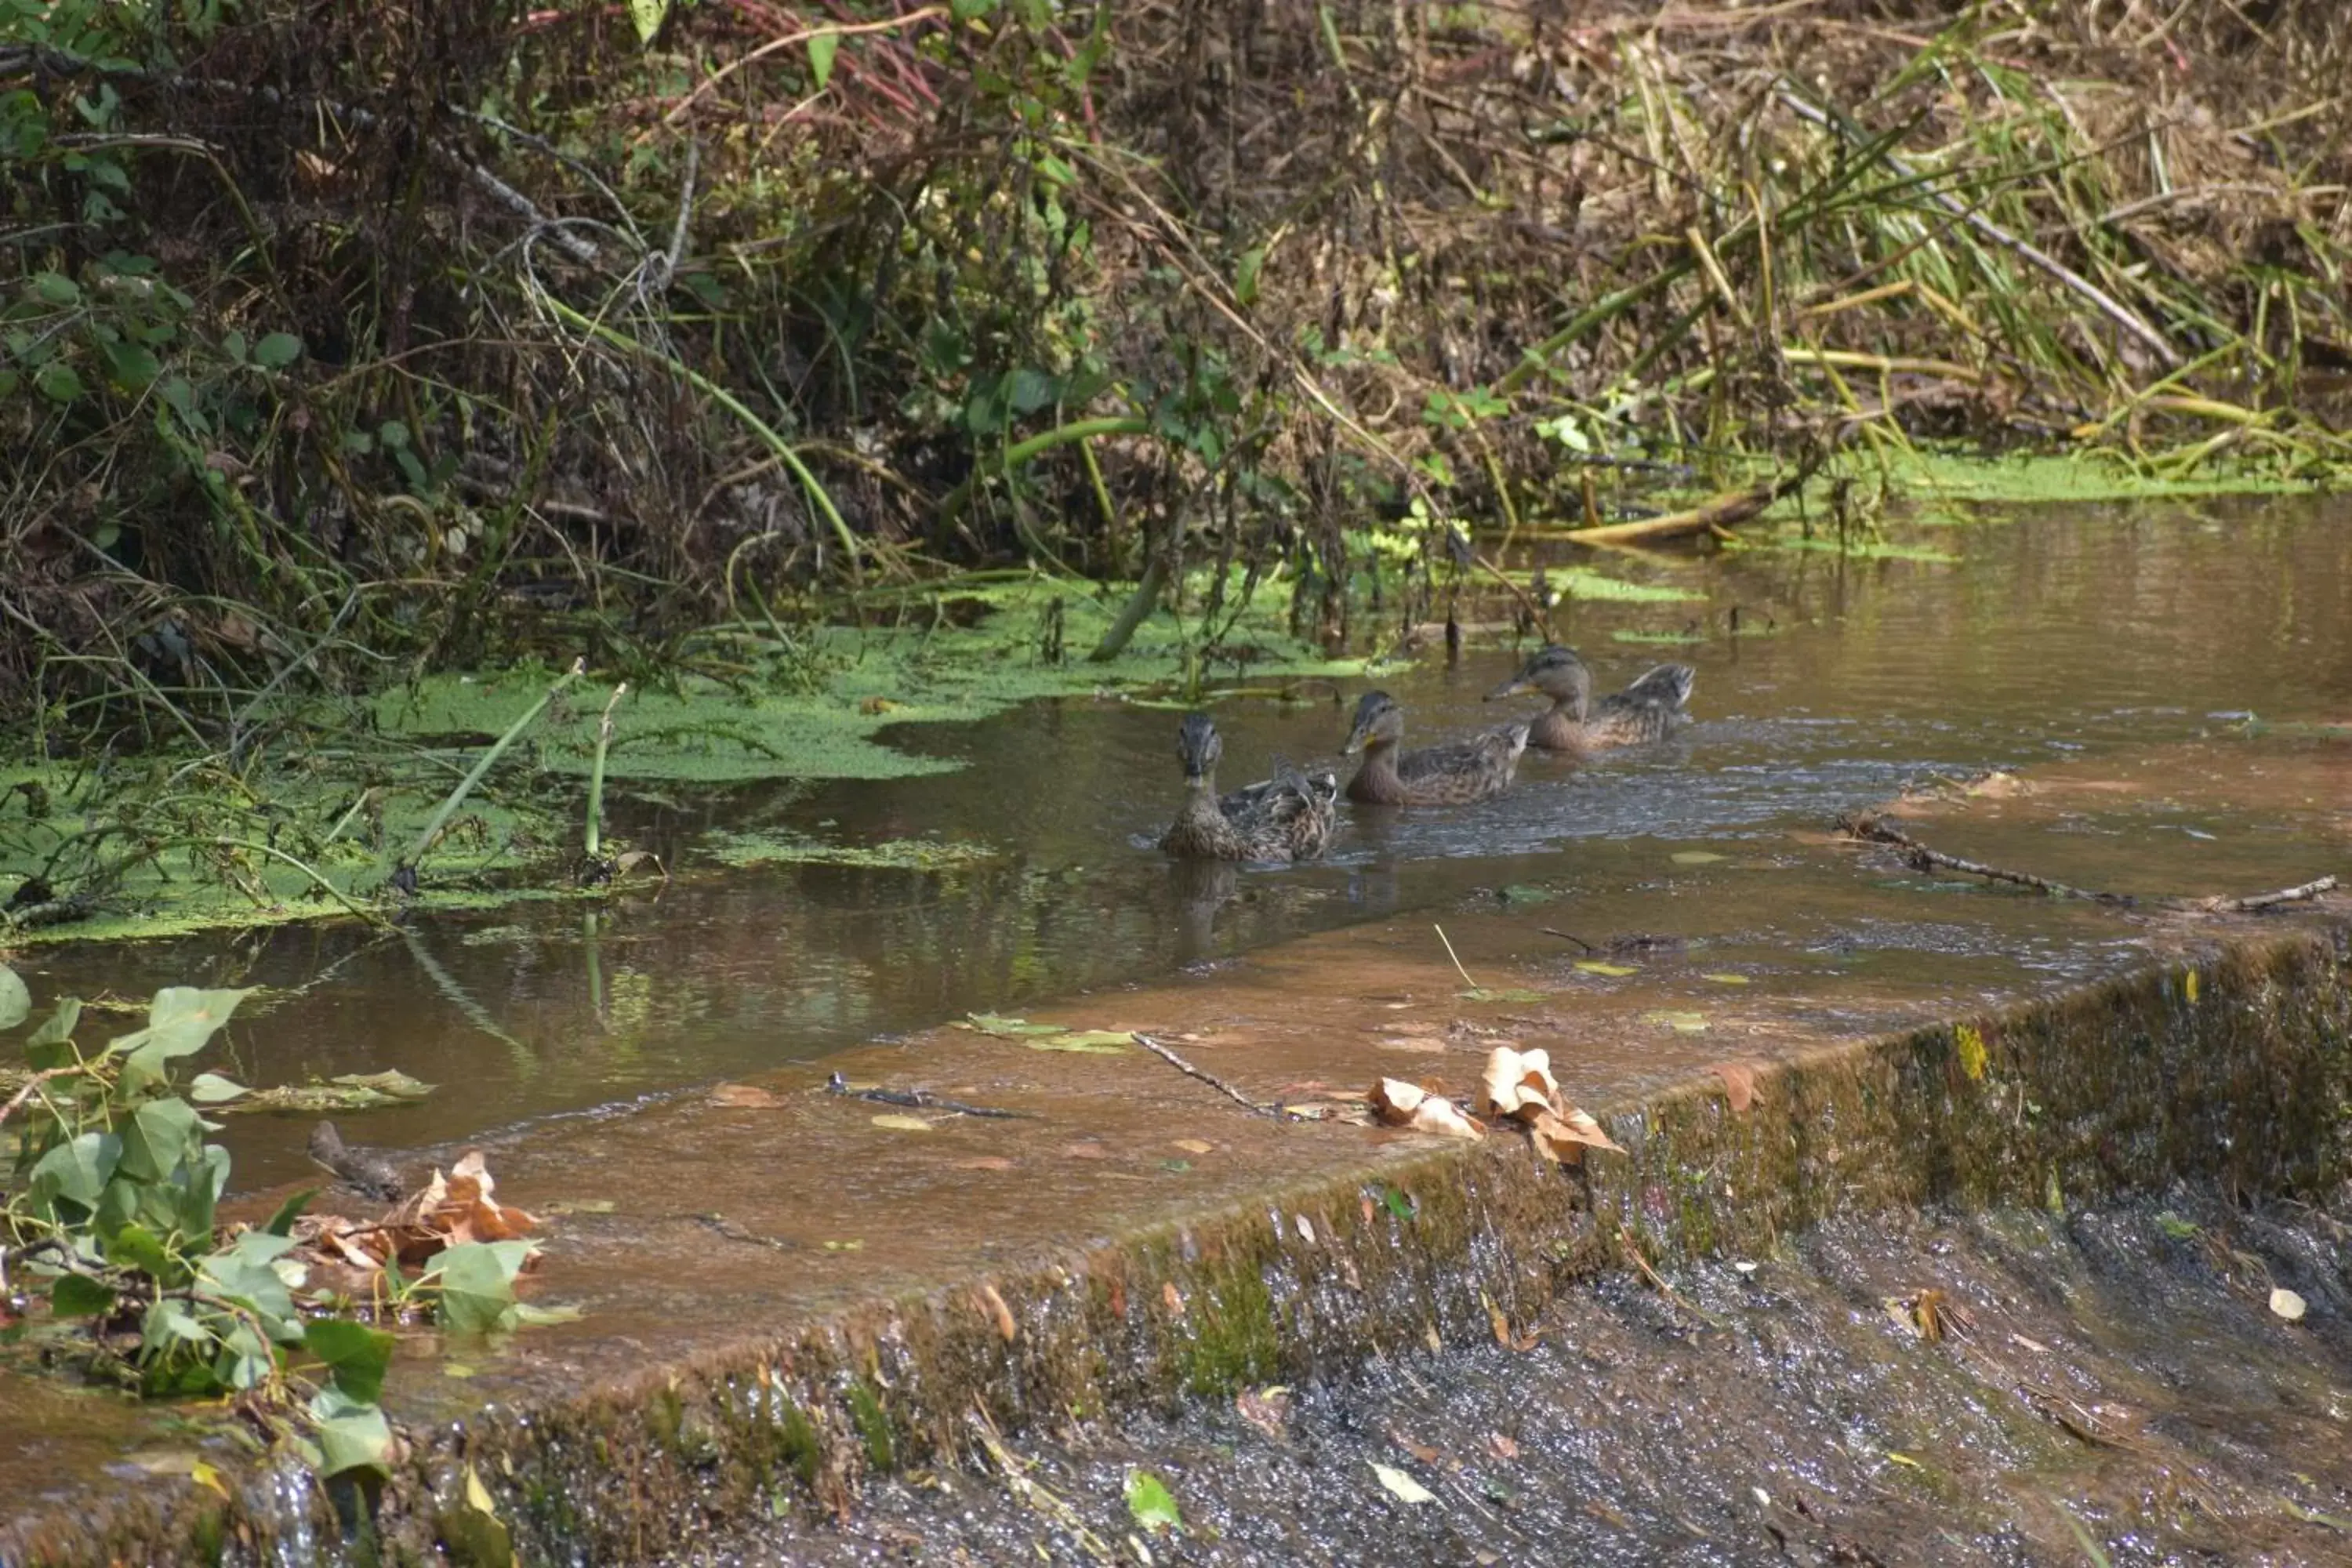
[0,0,2352,931]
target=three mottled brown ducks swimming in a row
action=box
[1160,644,1696,860]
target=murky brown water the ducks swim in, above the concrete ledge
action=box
[21,501,2352,1187]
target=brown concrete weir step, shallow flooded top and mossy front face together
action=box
[0,869,2352,1566]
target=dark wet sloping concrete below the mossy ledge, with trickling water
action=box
[663,1187,2352,1568]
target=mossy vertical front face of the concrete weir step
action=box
[0,926,2352,1566]
